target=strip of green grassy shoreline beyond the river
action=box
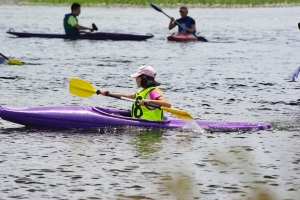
[0,0,300,8]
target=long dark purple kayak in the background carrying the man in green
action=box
[6,30,153,41]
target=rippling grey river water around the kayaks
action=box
[0,5,300,199]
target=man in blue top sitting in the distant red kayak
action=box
[169,6,196,35]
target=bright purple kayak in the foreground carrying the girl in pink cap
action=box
[0,106,271,131]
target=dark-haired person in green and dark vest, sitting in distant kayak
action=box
[64,3,94,34]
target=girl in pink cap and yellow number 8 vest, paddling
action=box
[101,65,171,120]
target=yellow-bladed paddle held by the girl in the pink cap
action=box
[69,78,193,120]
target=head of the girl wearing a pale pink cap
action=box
[131,65,160,89]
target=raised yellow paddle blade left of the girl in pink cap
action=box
[69,78,97,98]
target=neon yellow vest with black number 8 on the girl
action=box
[131,87,163,120]
